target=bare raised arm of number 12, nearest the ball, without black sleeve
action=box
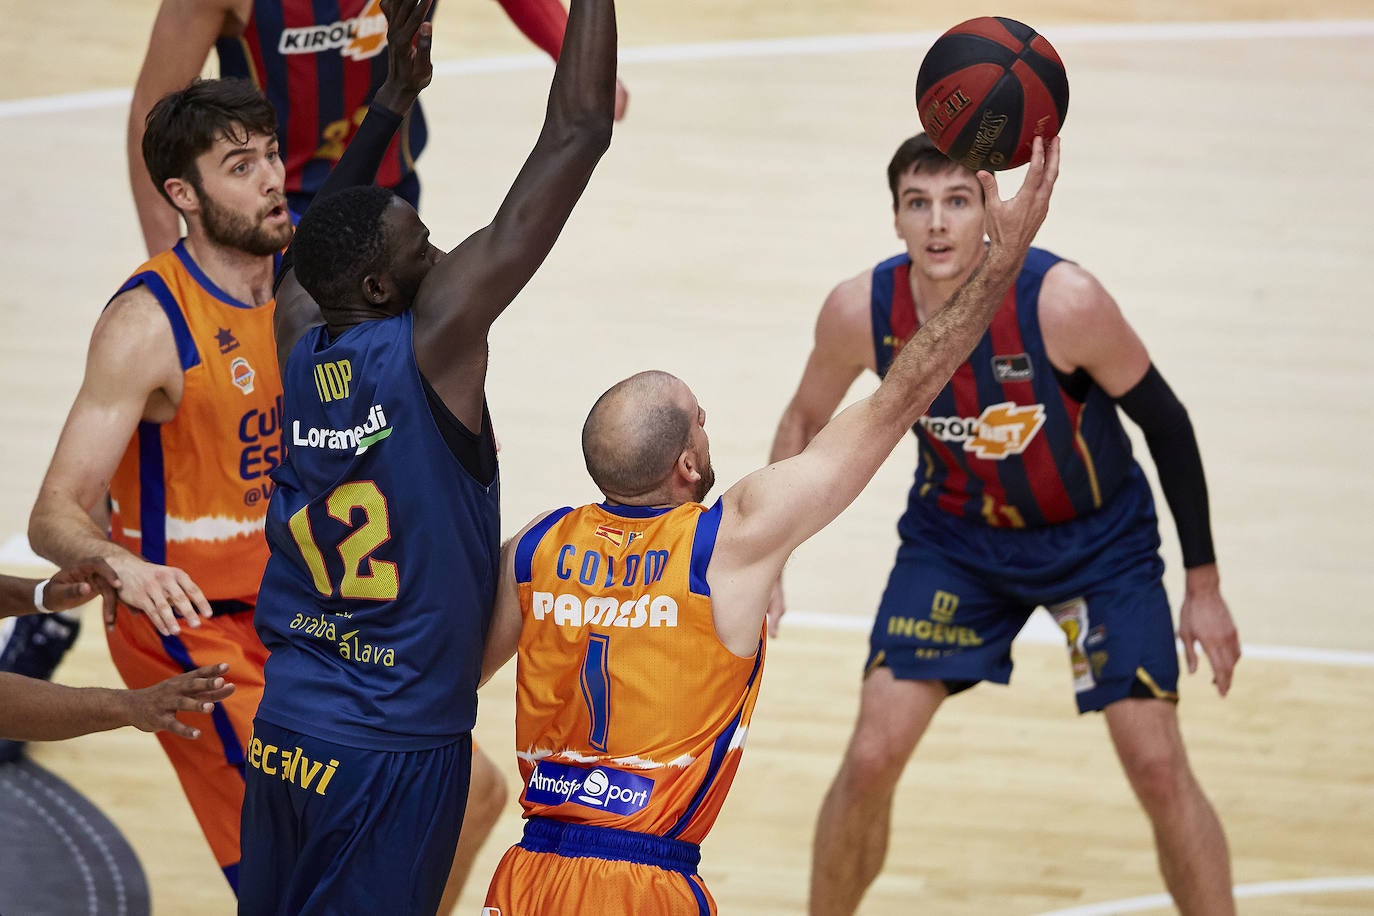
[414,0,616,430]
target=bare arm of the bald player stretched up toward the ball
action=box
[708,139,1059,651]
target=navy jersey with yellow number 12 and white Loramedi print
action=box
[256,312,500,751]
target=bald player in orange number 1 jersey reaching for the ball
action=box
[484,140,1059,916]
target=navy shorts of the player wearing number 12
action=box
[239,718,473,916]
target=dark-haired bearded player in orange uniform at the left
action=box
[29,80,291,886]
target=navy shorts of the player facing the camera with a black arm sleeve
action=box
[864,468,1179,713]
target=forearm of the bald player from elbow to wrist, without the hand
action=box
[872,246,1026,430]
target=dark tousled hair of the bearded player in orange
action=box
[143,80,276,206]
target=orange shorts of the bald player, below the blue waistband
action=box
[482,846,716,916]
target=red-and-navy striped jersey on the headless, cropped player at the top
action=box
[214,0,434,200]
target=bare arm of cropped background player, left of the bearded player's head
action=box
[125,0,251,255]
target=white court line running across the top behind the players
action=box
[0,19,1374,119]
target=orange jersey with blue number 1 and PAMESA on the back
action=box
[515,501,764,843]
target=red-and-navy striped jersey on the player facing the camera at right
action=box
[871,249,1135,537]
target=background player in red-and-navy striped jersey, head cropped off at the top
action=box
[128,0,628,255]
